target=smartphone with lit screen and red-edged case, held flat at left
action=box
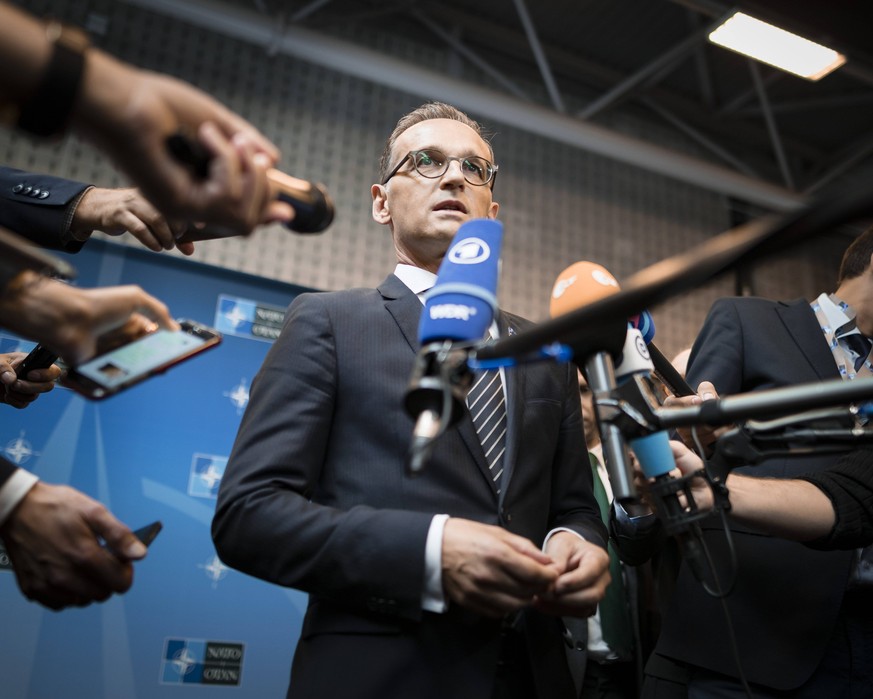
[61,320,221,400]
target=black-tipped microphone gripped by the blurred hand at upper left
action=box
[166,133,334,243]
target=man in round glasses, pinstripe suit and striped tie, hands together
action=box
[213,103,609,699]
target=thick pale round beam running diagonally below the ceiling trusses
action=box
[124,0,805,211]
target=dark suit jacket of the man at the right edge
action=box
[656,298,853,689]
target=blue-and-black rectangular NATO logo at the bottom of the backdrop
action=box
[161,638,245,687]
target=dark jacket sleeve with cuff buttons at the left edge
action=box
[0,167,91,252]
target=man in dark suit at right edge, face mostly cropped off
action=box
[643,230,873,699]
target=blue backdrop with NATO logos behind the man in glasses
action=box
[0,241,314,699]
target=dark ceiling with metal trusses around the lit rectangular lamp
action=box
[128,0,873,216]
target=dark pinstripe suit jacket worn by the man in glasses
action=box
[213,275,605,699]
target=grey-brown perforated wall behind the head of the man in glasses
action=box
[0,0,847,354]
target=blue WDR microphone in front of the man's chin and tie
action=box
[404,218,503,475]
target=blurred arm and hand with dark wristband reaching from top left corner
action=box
[0,2,294,234]
